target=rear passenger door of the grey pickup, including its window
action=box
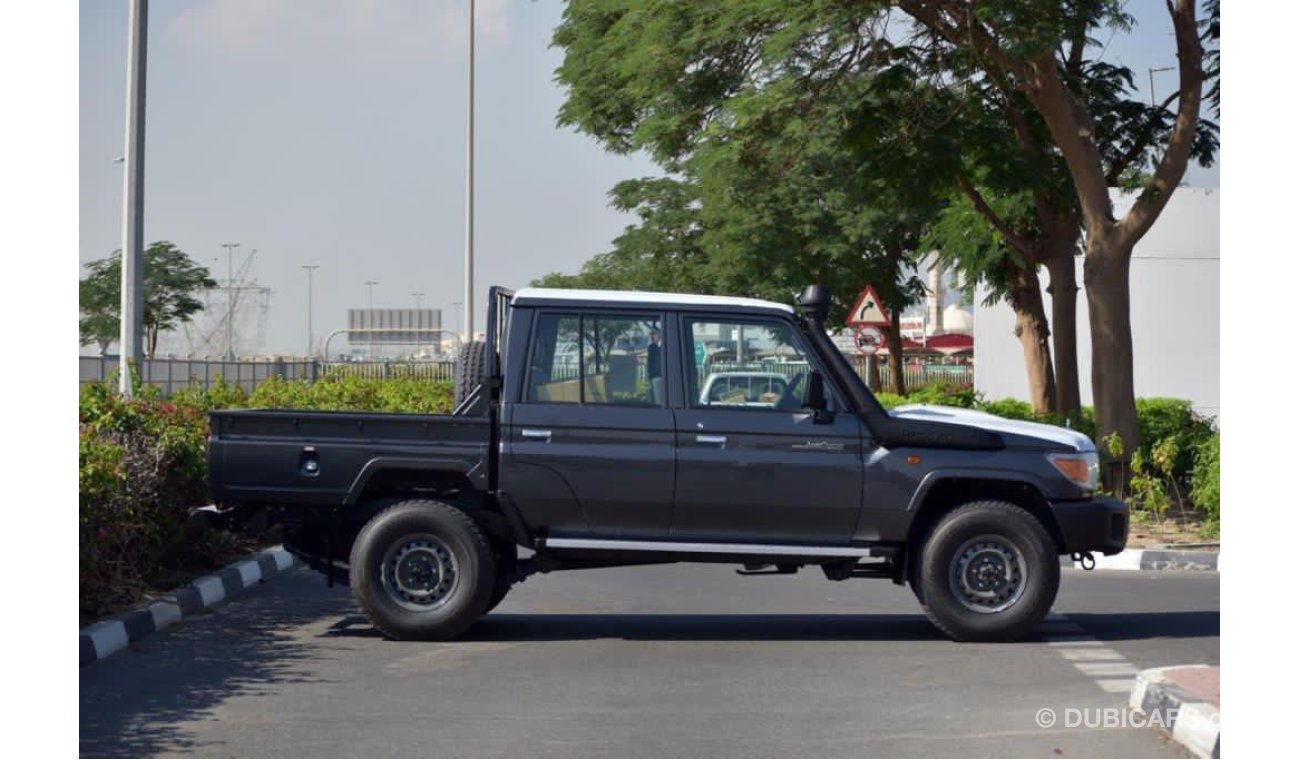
[501,309,675,538]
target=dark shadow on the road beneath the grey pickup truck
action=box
[325,611,1219,642]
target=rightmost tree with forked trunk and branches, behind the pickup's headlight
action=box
[897,0,1217,467]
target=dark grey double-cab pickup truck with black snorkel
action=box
[208,286,1128,640]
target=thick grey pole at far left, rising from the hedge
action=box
[117,0,150,398]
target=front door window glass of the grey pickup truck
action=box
[685,320,837,411]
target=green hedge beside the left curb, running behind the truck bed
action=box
[78,377,452,612]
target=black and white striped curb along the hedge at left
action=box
[81,546,298,668]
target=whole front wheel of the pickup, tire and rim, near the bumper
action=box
[917,501,1061,642]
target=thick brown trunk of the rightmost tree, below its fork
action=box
[1083,233,1141,488]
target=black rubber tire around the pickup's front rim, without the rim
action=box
[913,501,1061,642]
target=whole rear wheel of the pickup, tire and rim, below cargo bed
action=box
[351,499,497,639]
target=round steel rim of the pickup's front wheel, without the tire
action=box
[948,535,1028,614]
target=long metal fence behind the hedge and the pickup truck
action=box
[81,356,975,394]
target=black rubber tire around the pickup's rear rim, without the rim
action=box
[350,499,497,640]
